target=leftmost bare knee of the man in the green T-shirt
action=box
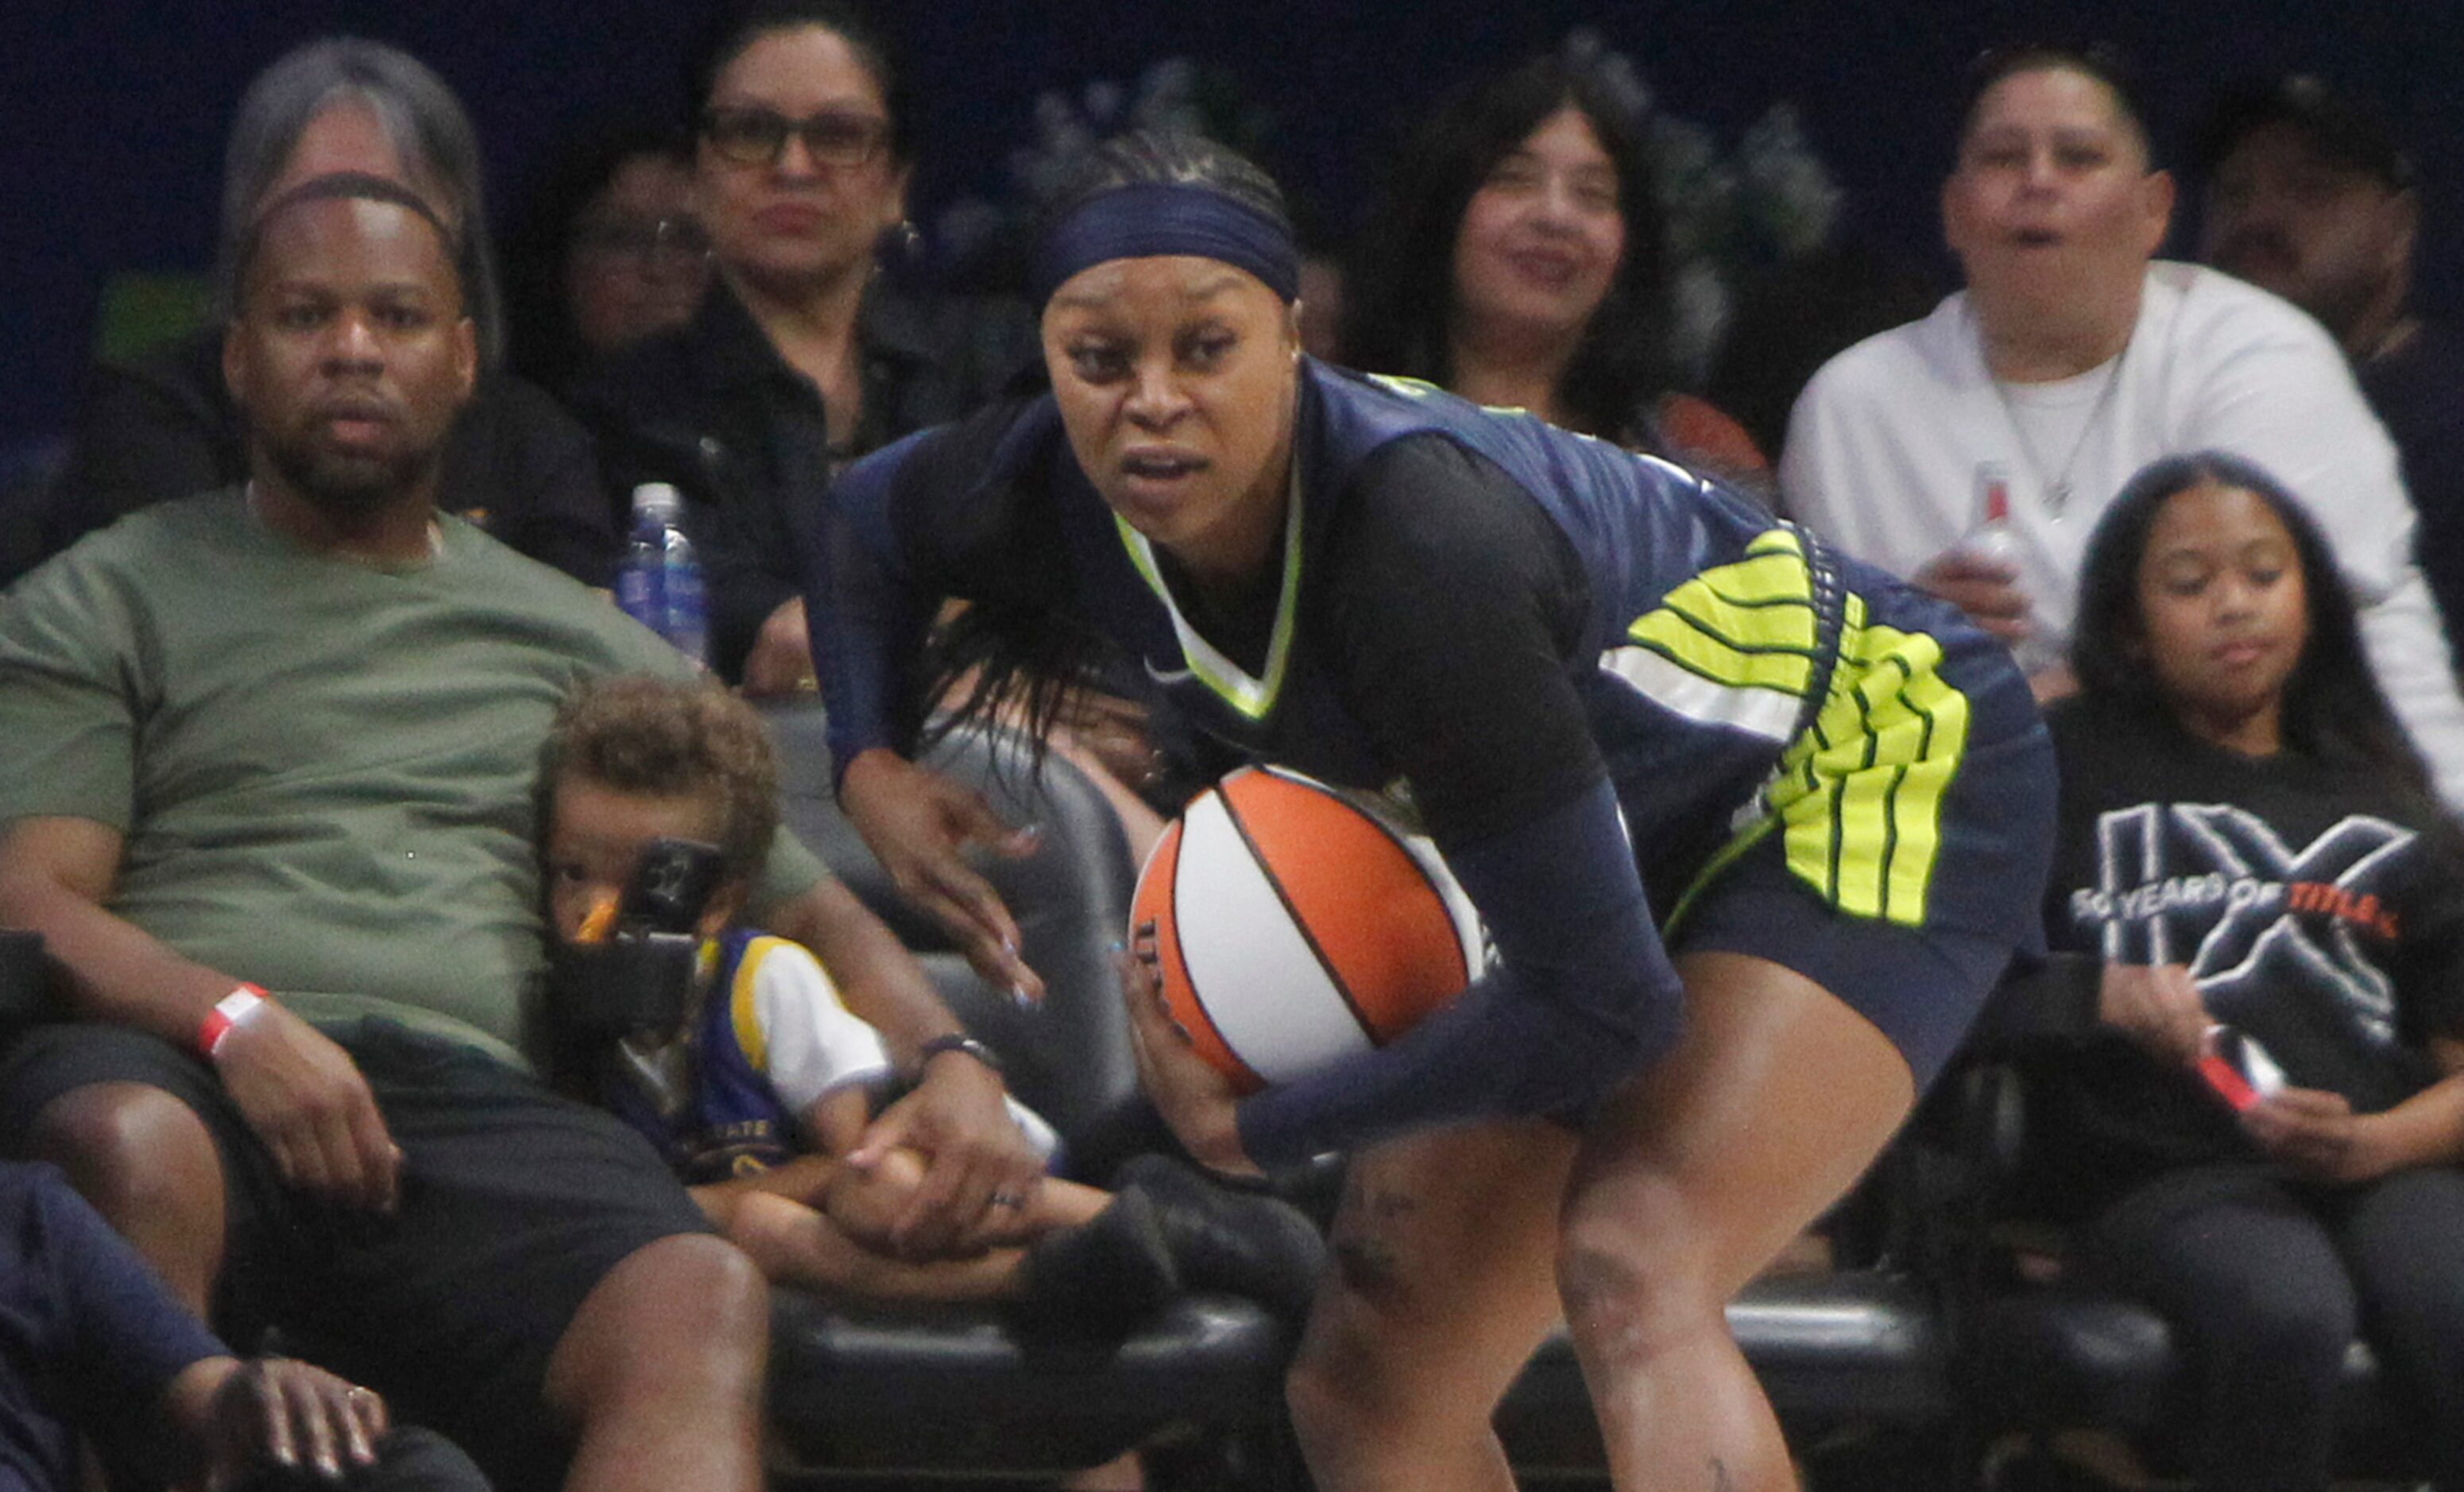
[27,1084,222,1236]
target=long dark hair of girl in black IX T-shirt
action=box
[2070,450,2435,802]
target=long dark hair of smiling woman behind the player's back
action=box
[1340,52,1668,439]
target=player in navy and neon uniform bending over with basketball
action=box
[808,135,2052,1490]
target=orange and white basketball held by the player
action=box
[1131,766,1486,1093]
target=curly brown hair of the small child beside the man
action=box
[540,674,779,879]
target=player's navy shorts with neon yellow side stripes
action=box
[1665,578,2057,1093]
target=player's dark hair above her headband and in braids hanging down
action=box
[909,130,1291,763]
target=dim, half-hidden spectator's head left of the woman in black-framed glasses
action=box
[505,116,710,389]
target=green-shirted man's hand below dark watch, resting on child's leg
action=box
[845,1051,1045,1258]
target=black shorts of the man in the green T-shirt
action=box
[0,1019,710,1487]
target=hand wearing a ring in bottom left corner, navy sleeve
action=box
[191,1357,387,1492]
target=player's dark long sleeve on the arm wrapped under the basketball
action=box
[1240,441,1683,1162]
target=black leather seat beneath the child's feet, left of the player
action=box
[766,704,1291,1485]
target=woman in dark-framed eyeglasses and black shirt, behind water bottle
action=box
[574,0,1035,694]
